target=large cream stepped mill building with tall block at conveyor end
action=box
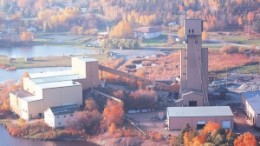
[10,57,100,120]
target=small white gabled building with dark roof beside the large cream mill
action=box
[44,104,79,128]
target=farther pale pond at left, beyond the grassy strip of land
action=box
[0,46,96,58]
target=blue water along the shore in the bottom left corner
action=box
[0,126,97,146]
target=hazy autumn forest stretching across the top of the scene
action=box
[0,0,260,33]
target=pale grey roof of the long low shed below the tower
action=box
[167,106,233,117]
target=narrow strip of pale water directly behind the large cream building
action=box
[0,67,71,82]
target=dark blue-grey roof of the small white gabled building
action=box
[50,104,79,115]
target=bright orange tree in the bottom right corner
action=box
[234,132,257,146]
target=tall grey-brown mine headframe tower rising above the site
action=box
[180,19,209,106]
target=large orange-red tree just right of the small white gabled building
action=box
[103,100,124,127]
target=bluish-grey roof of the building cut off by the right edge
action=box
[241,90,260,114]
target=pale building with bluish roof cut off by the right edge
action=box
[241,90,260,127]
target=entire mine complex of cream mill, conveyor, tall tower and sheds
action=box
[10,19,260,130]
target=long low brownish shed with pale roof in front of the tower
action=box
[167,106,234,130]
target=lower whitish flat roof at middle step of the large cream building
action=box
[37,81,81,89]
